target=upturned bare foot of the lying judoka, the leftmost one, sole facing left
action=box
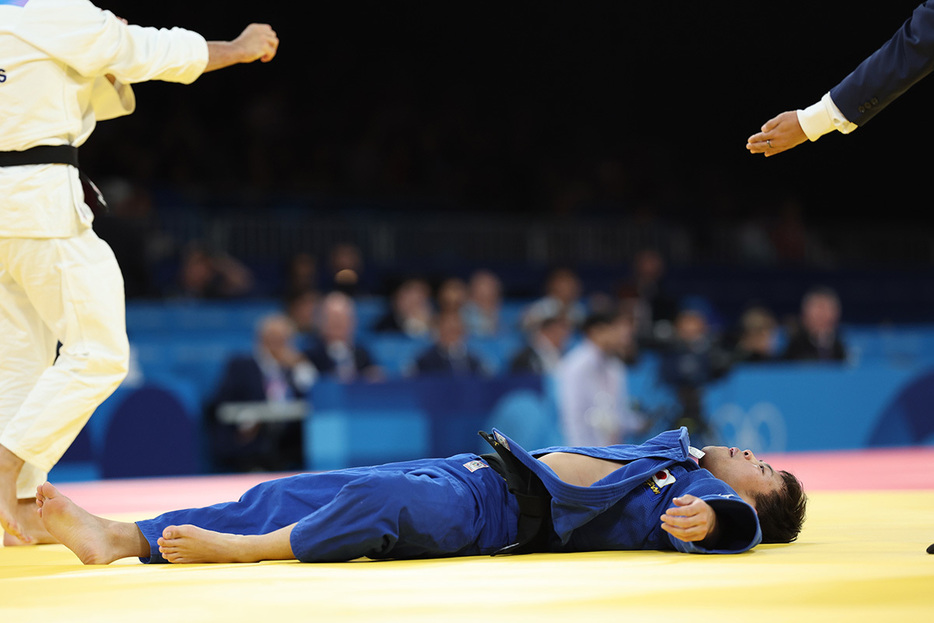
[36,483,149,565]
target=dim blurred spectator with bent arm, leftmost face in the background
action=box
[175,242,253,299]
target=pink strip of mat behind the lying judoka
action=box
[53,447,934,518]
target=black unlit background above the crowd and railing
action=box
[82,0,934,229]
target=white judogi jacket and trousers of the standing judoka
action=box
[0,0,208,498]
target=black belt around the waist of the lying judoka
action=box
[480,431,554,556]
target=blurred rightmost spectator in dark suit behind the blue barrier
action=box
[782,286,847,361]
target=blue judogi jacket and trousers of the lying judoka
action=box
[137,428,761,563]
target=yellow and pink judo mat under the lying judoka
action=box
[0,448,934,623]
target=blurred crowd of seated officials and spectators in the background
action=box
[197,245,847,470]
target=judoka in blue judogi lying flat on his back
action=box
[27,428,806,564]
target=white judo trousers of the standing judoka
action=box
[0,228,129,498]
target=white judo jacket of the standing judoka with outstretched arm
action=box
[0,0,208,238]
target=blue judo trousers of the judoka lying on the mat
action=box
[136,454,518,562]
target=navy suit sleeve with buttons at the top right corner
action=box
[830,0,934,126]
